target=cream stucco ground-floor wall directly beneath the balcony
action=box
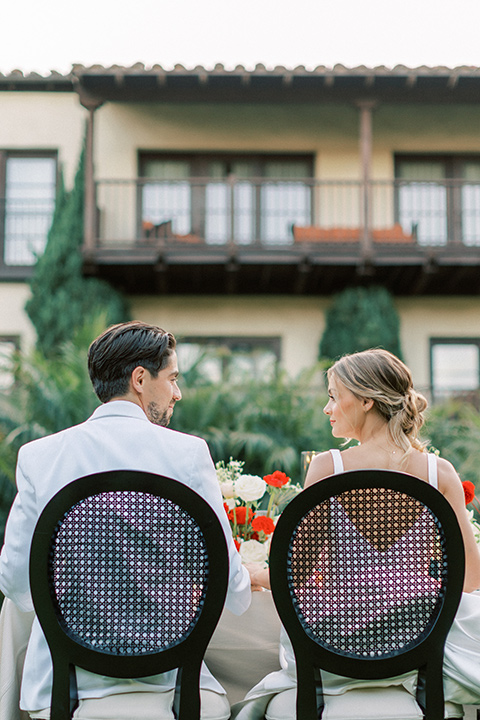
[129,297,480,389]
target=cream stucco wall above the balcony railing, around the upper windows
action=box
[95,103,480,179]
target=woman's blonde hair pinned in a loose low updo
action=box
[327,348,427,452]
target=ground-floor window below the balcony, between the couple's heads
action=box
[177,337,280,384]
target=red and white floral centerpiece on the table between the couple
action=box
[215,458,301,567]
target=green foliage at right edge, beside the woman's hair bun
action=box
[422,400,480,494]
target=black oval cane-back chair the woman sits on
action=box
[270,470,464,720]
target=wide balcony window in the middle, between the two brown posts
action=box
[140,154,313,244]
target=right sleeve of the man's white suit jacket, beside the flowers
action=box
[191,440,251,615]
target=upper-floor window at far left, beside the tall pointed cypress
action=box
[0,153,57,265]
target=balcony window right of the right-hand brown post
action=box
[395,156,480,245]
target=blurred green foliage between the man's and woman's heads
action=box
[172,365,335,482]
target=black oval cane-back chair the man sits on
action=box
[30,470,228,720]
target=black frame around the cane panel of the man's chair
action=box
[30,470,228,720]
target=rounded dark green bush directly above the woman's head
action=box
[320,287,402,360]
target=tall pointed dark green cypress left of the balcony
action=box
[25,142,128,357]
